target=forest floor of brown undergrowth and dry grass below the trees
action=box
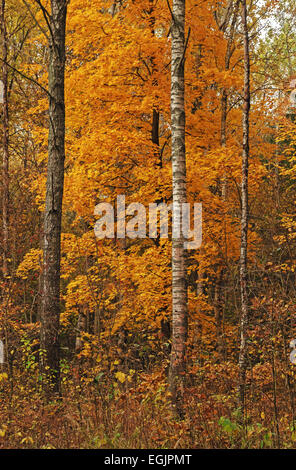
[0,362,296,449]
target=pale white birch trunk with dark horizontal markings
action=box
[169,0,187,416]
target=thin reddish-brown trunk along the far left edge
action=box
[1,0,9,277]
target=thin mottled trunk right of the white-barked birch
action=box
[239,0,250,409]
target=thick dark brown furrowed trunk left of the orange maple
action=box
[41,0,67,392]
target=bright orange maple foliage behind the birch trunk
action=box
[13,0,270,348]
